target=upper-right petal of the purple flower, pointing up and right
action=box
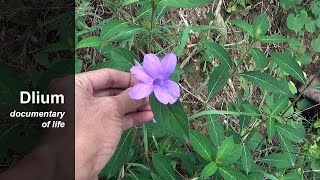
[161,53,177,79]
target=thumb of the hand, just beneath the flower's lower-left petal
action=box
[114,88,147,115]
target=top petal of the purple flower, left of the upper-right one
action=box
[143,54,162,78]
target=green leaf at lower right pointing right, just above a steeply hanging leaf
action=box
[276,124,304,142]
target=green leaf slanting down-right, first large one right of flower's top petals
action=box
[204,42,232,69]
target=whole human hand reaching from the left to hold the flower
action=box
[75,69,153,179]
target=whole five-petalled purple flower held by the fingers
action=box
[130,53,180,104]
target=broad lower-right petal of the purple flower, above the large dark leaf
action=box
[153,80,180,104]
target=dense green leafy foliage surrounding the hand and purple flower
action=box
[76,0,320,180]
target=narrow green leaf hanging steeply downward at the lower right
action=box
[278,133,297,167]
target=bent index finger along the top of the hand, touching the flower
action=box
[76,68,139,91]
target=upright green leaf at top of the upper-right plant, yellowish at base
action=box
[252,13,269,39]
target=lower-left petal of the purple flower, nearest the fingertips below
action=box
[129,83,153,99]
